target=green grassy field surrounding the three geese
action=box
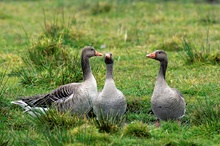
[0,0,220,146]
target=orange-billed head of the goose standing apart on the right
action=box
[146,50,167,62]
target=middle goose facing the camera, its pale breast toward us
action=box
[93,53,127,120]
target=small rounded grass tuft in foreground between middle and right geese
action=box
[123,121,150,138]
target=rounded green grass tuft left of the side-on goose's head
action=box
[28,36,70,70]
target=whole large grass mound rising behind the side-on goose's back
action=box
[17,13,82,86]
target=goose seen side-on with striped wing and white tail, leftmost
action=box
[11,46,102,115]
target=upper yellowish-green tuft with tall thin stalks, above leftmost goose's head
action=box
[39,12,95,50]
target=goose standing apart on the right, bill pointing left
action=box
[147,50,186,127]
